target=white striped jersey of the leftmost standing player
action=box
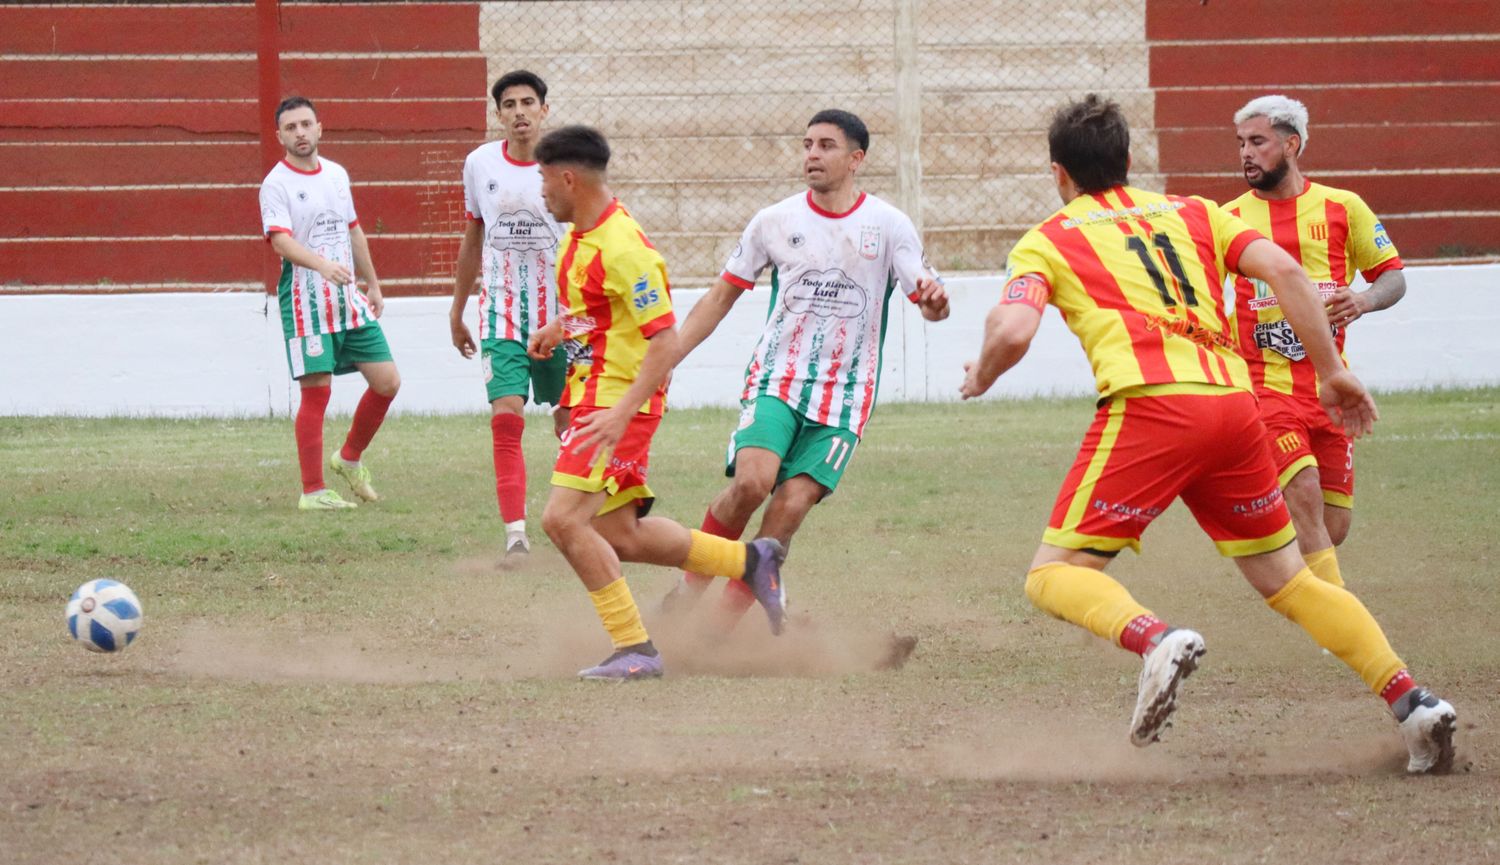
[261,157,375,339]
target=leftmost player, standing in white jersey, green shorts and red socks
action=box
[261,96,401,511]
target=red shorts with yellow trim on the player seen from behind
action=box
[1043,391,1296,556]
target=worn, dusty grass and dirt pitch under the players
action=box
[0,391,1500,864]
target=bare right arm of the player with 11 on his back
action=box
[1235,238,1380,438]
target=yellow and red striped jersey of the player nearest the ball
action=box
[558,199,677,415]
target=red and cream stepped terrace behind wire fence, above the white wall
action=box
[20,0,1500,294]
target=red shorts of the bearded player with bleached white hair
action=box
[1259,390,1355,508]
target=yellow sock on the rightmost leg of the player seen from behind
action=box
[1266,568,1406,694]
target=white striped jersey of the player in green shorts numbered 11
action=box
[723,192,926,435]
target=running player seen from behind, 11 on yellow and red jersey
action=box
[962,94,1457,774]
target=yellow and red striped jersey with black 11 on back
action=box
[1001,186,1260,399]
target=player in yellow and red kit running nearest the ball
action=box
[528,126,786,681]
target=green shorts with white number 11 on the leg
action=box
[725,396,860,495]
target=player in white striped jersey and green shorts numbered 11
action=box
[663,109,948,629]
